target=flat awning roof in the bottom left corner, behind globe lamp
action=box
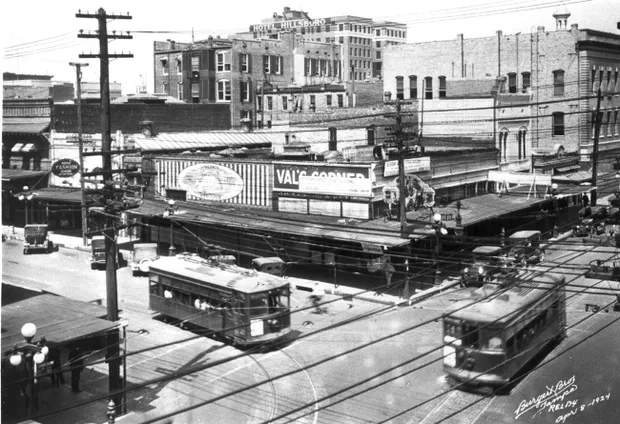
[2,294,118,357]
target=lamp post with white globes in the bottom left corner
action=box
[9,322,49,415]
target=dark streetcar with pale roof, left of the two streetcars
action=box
[149,253,291,347]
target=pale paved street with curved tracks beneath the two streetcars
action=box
[3,234,620,424]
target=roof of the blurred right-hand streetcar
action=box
[446,270,563,324]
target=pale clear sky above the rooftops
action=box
[0,0,620,94]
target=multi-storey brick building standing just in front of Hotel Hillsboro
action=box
[154,33,349,128]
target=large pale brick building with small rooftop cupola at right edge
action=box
[384,10,620,176]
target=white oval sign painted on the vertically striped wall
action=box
[178,163,244,200]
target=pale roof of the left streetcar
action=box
[149,256,289,293]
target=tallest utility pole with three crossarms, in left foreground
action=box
[75,8,133,414]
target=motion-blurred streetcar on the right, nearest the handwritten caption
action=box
[443,269,566,389]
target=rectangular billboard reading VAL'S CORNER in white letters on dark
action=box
[273,163,374,197]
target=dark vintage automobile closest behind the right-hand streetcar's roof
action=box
[461,246,507,287]
